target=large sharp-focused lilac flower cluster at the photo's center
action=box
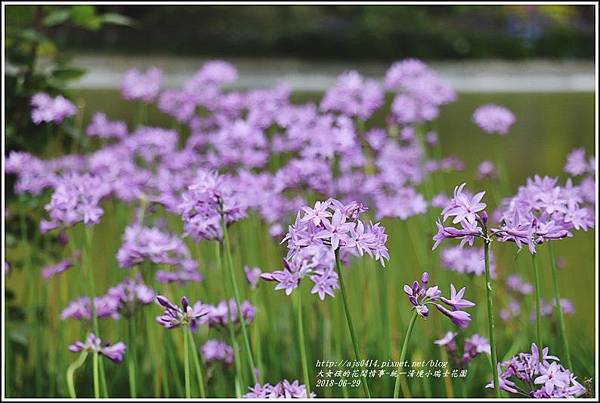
[261,199,389,300]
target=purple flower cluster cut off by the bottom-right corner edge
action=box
[486,343,586,399]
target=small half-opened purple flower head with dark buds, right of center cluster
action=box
[404,272,475,328]
